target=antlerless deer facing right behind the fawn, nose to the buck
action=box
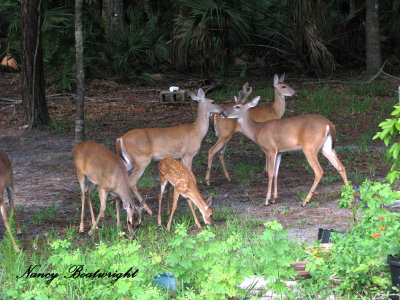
[117,89,223,206]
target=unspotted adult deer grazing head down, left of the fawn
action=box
[72,142,141,236]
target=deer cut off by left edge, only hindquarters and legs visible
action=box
[0,150,21,252]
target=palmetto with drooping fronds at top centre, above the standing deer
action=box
[170,0,251,72]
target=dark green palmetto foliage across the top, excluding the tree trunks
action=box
[0,0,400,89]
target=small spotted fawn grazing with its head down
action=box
[158,157,213,230]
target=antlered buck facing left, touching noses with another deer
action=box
[221,85,348,206]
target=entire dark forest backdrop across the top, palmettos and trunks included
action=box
[0,0,400,134]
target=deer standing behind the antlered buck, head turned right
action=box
[206,74,297,185]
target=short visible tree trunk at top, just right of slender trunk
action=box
[103,0,125,40]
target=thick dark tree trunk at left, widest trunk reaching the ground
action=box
[21,0,50,127]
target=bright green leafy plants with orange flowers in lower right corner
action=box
[303,180,400,298]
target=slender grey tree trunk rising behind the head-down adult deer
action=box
[74,0,85,145]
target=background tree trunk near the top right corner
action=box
[365,0,382,77]
